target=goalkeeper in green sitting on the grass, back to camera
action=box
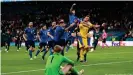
[45,45,84,75]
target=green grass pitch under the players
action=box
[1,46,133,75]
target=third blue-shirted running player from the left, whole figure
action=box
[47,22,56,55]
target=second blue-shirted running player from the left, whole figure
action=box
[34,25,48,58]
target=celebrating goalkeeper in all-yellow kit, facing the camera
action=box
[79,15,93,62]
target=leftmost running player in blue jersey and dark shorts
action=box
[23,22,35,60]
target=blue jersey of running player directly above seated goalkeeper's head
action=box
[54,26,64,41]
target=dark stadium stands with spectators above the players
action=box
[1,1,133,42]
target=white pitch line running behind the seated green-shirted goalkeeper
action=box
[2,60,133,75]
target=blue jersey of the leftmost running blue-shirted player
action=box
[25,27,35,41]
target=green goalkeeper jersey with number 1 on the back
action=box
[45,53,74,75]
